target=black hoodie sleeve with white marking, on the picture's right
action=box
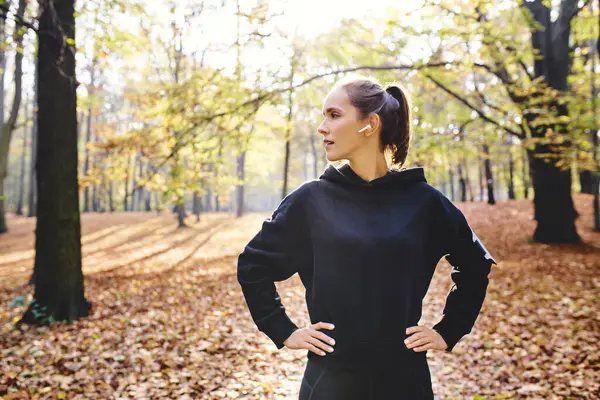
[433,195,497,352]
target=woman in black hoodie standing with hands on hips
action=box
[238,78,496,400]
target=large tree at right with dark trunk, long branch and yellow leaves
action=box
[412,0,589,243]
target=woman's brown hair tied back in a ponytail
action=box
[336,77,411,165]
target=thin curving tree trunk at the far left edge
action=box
[0,0,25,233]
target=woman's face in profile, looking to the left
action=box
[317,88,373,161]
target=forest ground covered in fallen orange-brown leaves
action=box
[0,195,600,400]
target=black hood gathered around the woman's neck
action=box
[319,163,427,188]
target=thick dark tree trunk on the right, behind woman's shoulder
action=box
[522,0,581,243]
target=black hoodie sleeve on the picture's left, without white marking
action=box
[237,186,312,349]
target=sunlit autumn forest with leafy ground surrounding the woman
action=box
[0,0,600,400]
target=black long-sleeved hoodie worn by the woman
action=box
[238,164,496,367]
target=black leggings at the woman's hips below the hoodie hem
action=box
[298,358,434,400]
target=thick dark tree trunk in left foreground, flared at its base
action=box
[19,0,91,325]
